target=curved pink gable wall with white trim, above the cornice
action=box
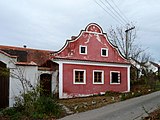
[54,24,128,63]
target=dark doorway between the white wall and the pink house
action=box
[40,74,52,96]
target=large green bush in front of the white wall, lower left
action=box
[2,84,62,120]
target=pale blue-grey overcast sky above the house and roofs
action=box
[0,0,160,61]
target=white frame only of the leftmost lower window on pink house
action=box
[73,69,86,84]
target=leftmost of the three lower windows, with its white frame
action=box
[73,69,86,84]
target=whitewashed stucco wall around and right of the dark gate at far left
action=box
[0,53,38,107]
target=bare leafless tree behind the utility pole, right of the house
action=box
[108,24,150,61]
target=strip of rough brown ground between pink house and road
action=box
[59,85,153,116]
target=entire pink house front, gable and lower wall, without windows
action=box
[52,23,129,97]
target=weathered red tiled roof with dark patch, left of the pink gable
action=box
[0,45,54,66]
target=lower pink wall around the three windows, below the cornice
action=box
[63,64,128,96]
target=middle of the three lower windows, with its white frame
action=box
[93,70,104,84]
